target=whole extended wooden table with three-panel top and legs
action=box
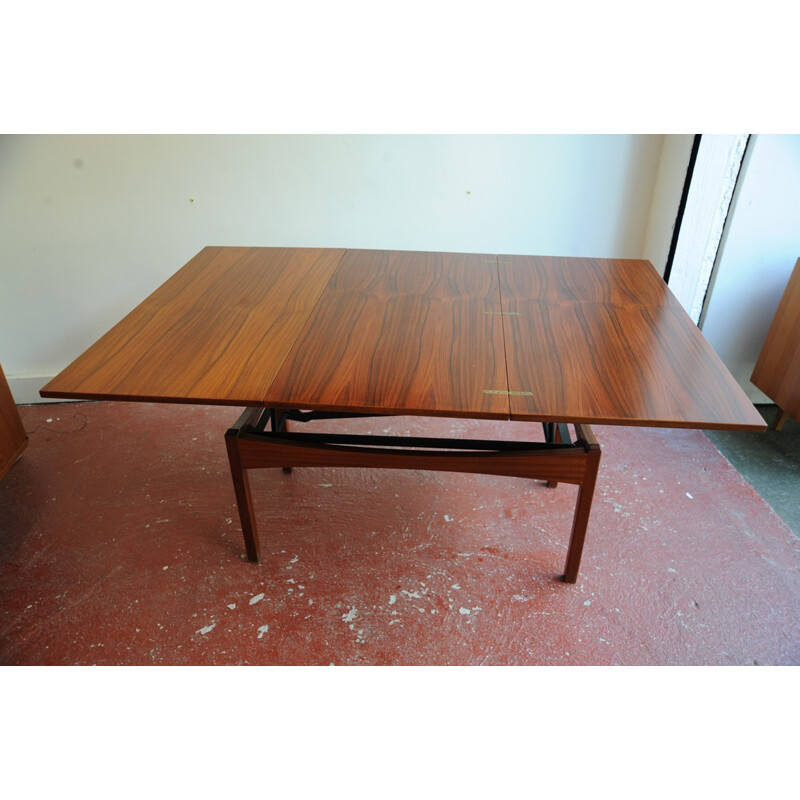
[41,247,766,583]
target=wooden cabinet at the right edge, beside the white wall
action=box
[750,258,800,430]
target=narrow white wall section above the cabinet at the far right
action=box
[701,134,800,403]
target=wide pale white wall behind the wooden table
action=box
[0,135,664,402]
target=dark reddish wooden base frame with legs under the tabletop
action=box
[225,407,601,583]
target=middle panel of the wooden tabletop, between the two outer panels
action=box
[265,250,509,418]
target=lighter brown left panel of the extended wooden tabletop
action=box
[41,247,344,405]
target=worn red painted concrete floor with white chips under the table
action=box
[0,403,800,665]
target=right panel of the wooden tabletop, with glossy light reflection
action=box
[498,256,765,430]
